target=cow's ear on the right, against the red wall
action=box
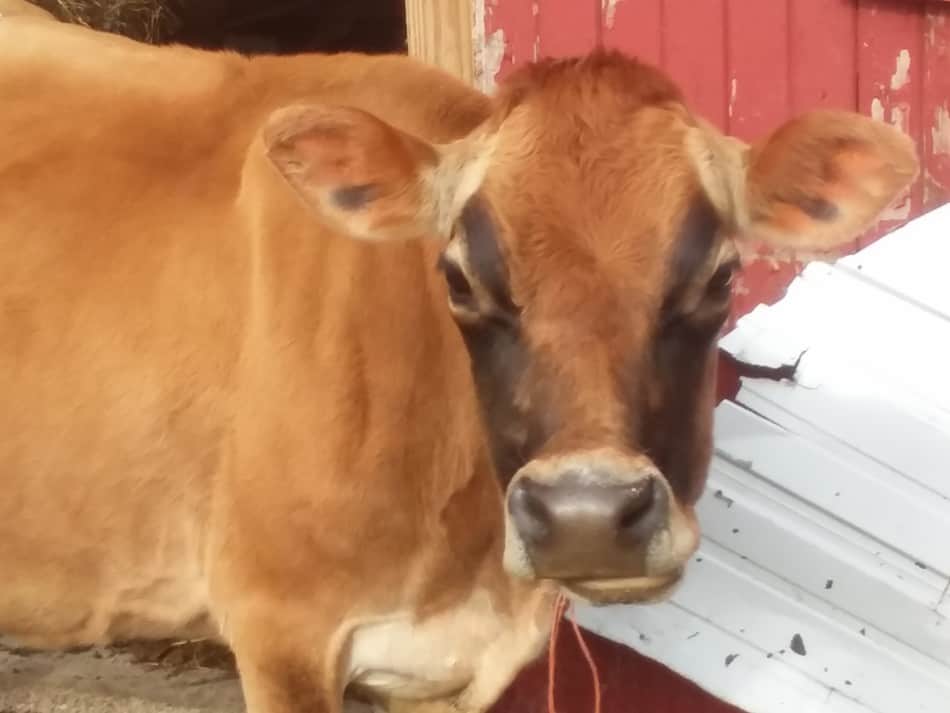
[687,111,918,251]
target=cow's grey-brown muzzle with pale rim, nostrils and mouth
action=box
[505,454,696,602]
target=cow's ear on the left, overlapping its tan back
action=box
[262,105,489,241]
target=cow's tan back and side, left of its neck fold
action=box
[0,19,484,645]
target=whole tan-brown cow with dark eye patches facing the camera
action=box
[0,9,918,713]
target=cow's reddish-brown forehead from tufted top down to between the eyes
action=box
[476,52,712,304]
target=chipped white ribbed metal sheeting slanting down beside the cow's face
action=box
[580,205,950,713]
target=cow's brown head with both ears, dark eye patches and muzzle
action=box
[265,53,917,602]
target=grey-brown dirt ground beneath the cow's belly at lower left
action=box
[0,639,244,713]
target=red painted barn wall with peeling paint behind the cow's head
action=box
[476,0,950,326]
